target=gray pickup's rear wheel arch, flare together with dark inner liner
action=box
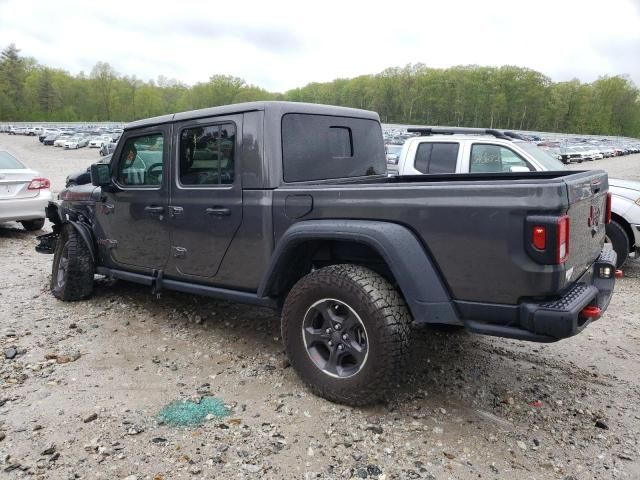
[258,220,462,325]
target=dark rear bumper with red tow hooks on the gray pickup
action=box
[458,245,616,342]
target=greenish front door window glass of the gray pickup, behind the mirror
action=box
[116,133,164,187]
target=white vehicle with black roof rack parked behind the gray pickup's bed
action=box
[387,127,640,267]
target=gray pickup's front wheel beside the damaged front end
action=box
[51,224,95,302]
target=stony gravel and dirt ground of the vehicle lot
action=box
[0,135,640,480]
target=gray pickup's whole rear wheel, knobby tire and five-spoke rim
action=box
[282,265,411,405]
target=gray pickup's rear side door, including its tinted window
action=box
[165,115,242,283]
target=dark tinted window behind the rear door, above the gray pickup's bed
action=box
[282,113,387,182]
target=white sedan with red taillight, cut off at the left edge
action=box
[0,151,53,230]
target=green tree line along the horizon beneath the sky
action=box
[0,44,640,137]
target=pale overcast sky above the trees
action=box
[0,0,640,92]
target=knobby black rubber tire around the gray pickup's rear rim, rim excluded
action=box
[282,265,411,406]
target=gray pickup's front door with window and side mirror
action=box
[96,125,171,273]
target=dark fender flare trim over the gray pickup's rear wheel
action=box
[258,220,463,325]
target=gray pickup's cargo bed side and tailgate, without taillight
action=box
[273,171,607,305]
